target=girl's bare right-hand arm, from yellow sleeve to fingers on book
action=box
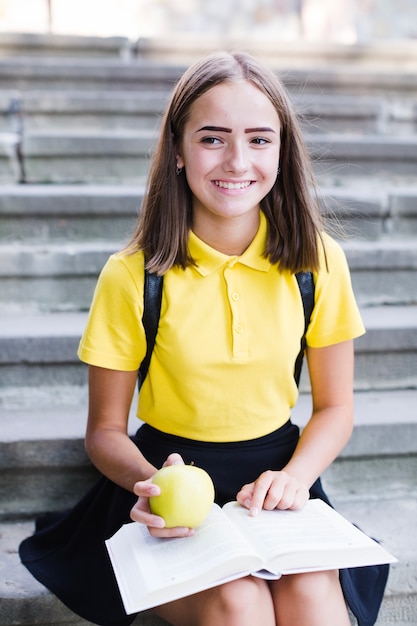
[237,341,354,515]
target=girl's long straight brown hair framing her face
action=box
[125,52,322,274]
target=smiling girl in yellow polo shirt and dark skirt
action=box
[21,53,387,626]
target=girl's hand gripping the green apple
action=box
[130,453,194,537]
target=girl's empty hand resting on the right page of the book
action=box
[236,470,309,516]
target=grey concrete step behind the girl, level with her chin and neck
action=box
[0,185,417,243]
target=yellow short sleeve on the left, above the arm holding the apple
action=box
[78,253,146,371]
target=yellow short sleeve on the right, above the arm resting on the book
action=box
[306,235,365,348]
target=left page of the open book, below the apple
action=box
[106,505,261,612]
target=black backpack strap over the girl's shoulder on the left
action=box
[138,269,163,389]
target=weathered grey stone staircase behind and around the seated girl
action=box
[0,33,417,626]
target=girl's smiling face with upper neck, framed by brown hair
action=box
[177,80,280,250]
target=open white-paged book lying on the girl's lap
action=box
[106,500,396,613]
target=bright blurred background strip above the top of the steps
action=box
[0,0,417,43]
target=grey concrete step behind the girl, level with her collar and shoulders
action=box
[0,236,417,311]
